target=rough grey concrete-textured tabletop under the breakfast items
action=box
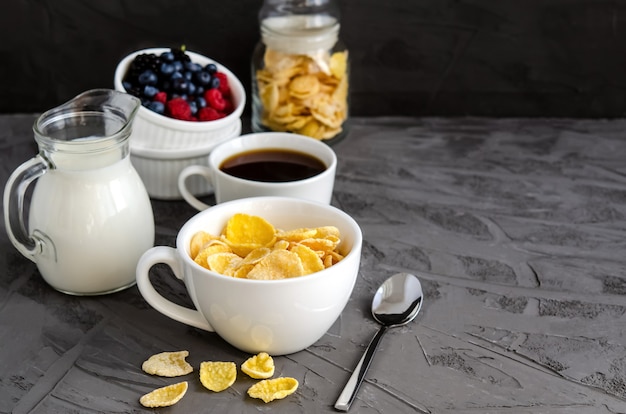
[0,114,626,414]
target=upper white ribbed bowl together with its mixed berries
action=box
[114,48,246,150]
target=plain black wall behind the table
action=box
[0,0,626,117]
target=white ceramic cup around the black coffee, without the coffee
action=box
[178,132,337,210]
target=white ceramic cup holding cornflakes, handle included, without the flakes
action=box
[137,197,362,355]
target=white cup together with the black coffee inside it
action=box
[178,132,337,211]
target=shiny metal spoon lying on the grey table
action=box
[335,273,423,411]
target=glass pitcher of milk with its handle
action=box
[3,89,154,295]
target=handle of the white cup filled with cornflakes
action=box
[136,246,215,332]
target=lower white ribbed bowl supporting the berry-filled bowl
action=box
[130,121,241,200]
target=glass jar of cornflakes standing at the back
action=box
[252,0,350,143]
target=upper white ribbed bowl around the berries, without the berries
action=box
[114,48,246,152]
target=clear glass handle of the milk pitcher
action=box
[3,155,54,262]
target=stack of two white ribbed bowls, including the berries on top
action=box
[114,48,246,199]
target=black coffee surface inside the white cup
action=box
[220,149,326,183]
